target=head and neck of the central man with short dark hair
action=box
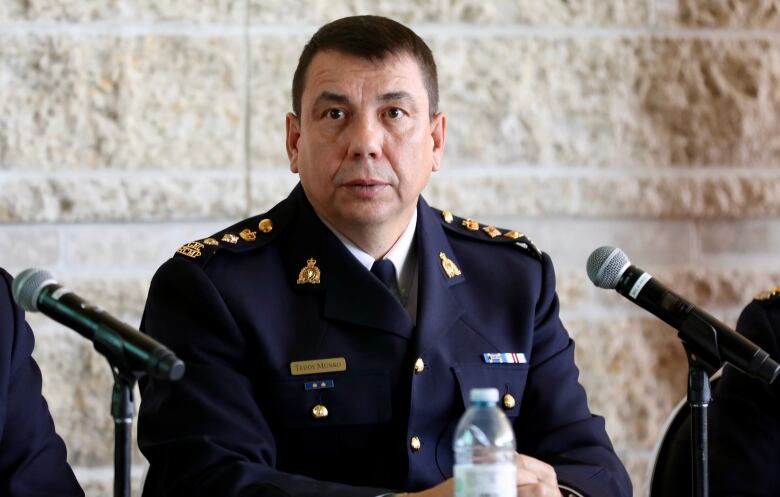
[286,16,446,257]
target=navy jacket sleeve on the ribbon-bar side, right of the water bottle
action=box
[515,254,632,497]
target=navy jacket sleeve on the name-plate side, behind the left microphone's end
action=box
[138,258,390,497]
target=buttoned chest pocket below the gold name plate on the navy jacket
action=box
[272,370,393,428]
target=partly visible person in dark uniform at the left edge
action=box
[0,268,84,497]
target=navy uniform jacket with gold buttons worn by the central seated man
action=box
[139,185,631,497]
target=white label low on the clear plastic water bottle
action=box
[453,463,517,497]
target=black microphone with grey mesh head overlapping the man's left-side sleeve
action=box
[11,268,184,381]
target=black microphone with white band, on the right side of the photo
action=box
[587,247,780,383]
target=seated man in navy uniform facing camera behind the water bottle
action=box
[139,16,631,497]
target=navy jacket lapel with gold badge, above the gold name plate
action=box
[288,185,413,338]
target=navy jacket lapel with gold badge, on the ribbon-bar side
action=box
[414,197,465,357]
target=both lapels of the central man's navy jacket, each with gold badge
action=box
[284,184,467,350]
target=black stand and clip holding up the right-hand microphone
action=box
[677,315,723,497]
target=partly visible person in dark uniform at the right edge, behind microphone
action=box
[710,287,780,497]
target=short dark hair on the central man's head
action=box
[292,16,439,116]
